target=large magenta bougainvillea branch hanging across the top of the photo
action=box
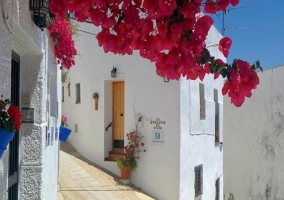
[50,0,261,106]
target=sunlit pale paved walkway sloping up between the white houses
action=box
[57,142,153,200]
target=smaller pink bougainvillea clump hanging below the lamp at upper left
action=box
[48,18,77,69]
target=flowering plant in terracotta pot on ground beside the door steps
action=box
[116,131,146,180]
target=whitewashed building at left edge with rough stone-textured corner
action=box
[0,0,61,200]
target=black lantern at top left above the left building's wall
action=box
[30,0,49,31]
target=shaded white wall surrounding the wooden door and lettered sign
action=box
[62,21,180,199]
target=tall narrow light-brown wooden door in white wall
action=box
[112,82,124,148]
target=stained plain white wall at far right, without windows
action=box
[224,65,284,200]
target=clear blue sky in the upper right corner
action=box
[209,0,284,69]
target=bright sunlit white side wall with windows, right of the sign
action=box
[180,27,225,200]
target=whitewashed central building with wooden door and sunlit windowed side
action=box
[62,23,224,200]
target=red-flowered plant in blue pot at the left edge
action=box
[0,98,22,158]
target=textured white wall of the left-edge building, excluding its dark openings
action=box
[0,0,61,200]
